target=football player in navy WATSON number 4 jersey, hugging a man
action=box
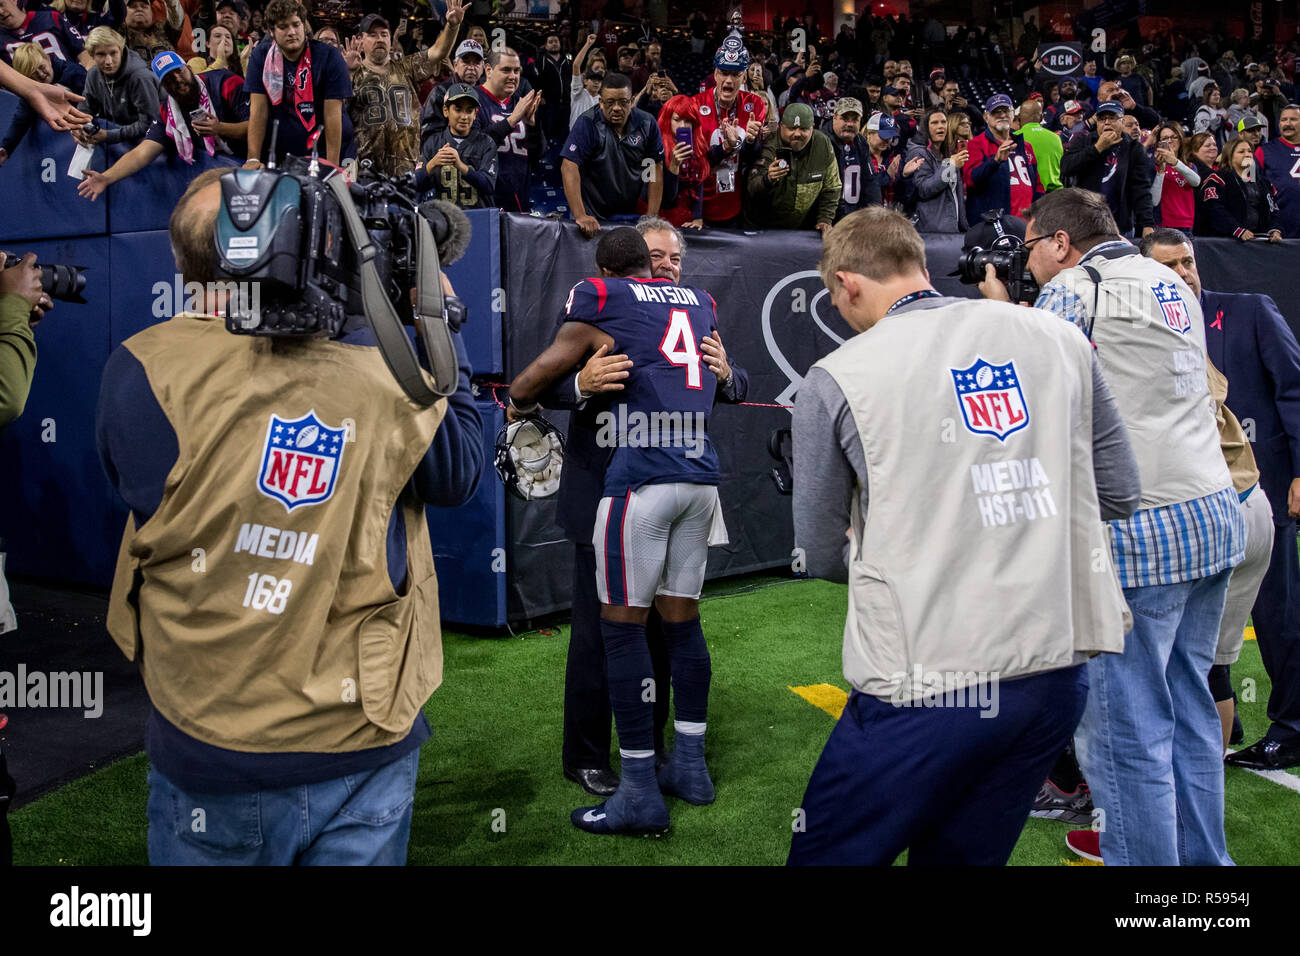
[510,228,720,834]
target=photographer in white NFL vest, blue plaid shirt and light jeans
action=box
[980,187,1245,866]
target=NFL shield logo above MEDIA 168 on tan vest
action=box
[257,408,346,511]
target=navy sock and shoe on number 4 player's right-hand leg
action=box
[658,618,714,806]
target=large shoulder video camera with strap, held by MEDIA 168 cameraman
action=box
[213,157,471,403]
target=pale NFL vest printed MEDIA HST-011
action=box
[816,302,1126,702]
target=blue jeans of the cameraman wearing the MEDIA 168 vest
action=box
[148,749,420,866]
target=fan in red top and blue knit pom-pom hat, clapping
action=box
[694,34,767,226]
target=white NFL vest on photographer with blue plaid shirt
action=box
[1054,250,1232,510]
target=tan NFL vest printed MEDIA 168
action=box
[108,313,446,753]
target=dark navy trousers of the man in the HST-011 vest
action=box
[788,665,1088,866]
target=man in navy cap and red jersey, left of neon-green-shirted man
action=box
[962,94,1045,222]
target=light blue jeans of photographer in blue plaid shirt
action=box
[1075,570,1232,866]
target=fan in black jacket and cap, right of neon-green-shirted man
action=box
[1061,100,1156,237]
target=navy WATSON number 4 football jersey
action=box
[562,278,718,497]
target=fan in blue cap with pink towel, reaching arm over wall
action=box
[77,49,248,202]
